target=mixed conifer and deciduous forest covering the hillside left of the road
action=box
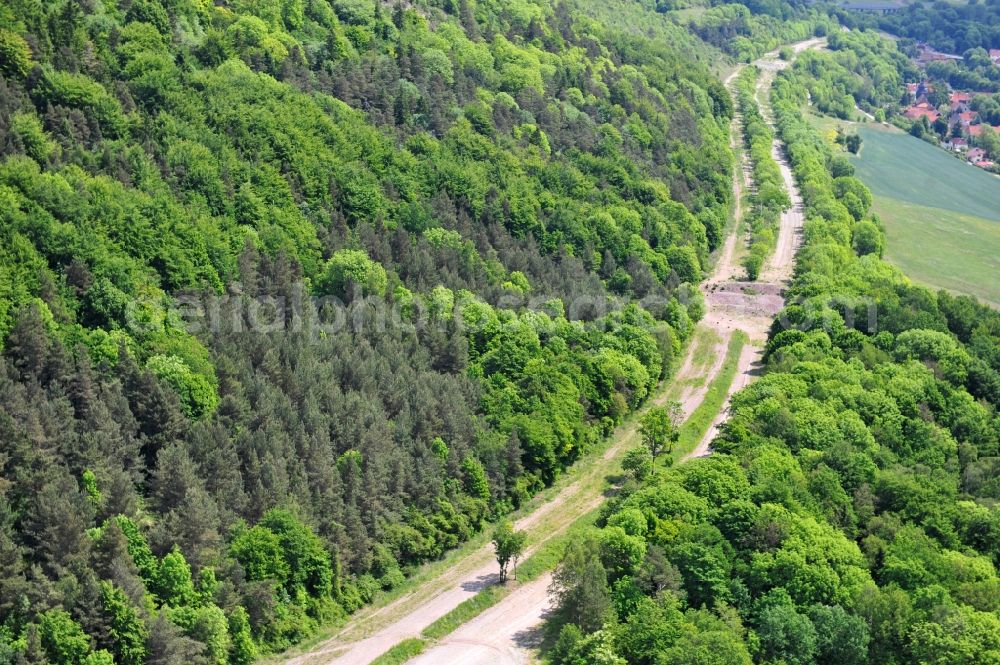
[0,0,732,665]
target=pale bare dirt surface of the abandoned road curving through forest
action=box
[285,40,821,665]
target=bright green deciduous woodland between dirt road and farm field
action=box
[549,41,1000,665]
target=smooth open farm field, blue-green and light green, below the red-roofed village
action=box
[852,125,1000,307]
